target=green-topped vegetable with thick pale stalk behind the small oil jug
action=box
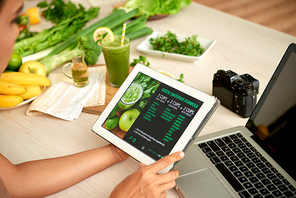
[40,36,102,74]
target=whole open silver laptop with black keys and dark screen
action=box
[175,43,296,198]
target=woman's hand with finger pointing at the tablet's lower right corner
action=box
[110,152,184,198]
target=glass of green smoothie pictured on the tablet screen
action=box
[118,82,143,111]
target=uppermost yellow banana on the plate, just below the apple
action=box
[0,72,50,87]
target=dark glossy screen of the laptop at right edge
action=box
[246,44,296,179]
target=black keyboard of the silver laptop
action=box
[198,133,296,198]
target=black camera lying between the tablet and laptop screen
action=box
[213,70,259,118]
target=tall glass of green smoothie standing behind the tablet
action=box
[101,35,130,87]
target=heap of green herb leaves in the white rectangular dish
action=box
[150,31,204,56]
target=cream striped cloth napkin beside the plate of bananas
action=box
[26,67,106,121]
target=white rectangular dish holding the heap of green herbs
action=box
[137,32,216,62]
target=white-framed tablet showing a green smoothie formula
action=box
[92,64,219,172]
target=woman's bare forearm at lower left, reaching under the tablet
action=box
[0,145,128,197]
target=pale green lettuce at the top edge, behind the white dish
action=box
[124,0,191,16]
